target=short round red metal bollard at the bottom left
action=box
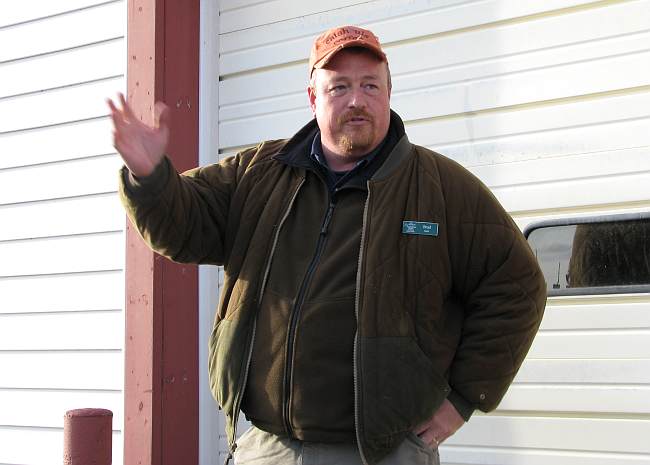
[63,408,113,465]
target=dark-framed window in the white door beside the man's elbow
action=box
[526,215,650,294]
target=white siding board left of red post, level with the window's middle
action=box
[0,232,124,277]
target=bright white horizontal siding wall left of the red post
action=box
[0,0,126,465]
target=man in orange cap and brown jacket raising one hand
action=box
[109,26,546,465]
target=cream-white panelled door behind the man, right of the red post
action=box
[219,0,650,465]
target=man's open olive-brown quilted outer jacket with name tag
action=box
[120,113,546,464]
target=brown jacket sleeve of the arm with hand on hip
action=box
[443,162,546,419]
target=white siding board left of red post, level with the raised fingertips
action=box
[0,77,124,133]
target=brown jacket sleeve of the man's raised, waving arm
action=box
[119,155,243,265]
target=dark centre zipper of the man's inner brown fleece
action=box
[282,197,336,438]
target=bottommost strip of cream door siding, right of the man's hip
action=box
[440,442,650,465]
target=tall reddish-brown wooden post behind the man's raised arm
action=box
[124,0,199,465]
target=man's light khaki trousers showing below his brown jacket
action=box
[234,427,440,465]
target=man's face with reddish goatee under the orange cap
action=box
[308,49,390,160]
